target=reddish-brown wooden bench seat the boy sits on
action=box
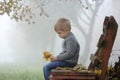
[50,69,96,80]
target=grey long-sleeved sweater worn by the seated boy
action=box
[57,32,80,64]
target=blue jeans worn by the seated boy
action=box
[43,61,75,80]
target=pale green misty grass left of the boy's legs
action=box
[0,66,44,80]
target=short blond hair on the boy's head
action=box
[54,18,71,31]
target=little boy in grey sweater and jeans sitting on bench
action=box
[43,18,80,80]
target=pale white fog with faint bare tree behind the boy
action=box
[0,0,120,74]
